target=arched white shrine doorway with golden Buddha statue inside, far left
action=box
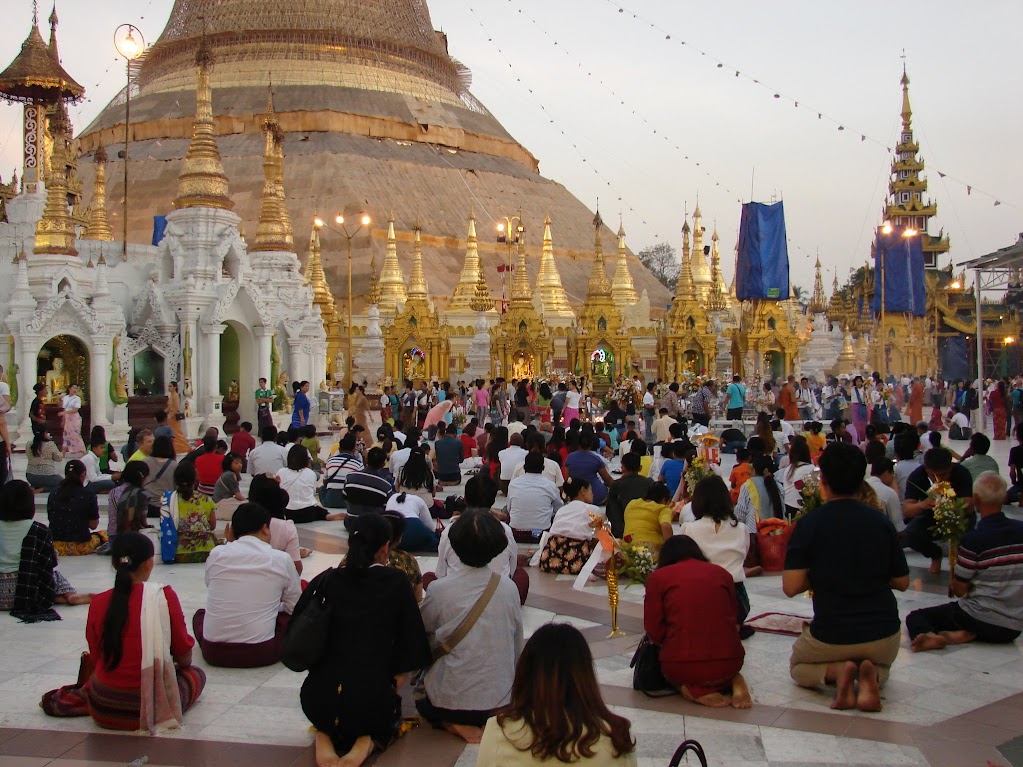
[36,334,89,447]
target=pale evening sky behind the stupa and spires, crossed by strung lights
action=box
[0,0,1023,290]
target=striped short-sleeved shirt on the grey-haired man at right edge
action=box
[955,511,1023,631]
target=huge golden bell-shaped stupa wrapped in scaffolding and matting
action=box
[70,0,669,309]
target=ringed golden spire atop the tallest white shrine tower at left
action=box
[174,34,234,211]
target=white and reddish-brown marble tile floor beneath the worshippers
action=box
[0,427,1023,767]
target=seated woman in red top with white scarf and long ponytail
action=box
[85,533,206,734]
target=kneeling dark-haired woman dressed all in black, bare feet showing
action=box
[292,514,433,767]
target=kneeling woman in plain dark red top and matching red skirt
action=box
[643,535,753,709]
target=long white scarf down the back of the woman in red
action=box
[138,583,182,735]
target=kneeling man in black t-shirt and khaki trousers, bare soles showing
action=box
[782,443,909,711]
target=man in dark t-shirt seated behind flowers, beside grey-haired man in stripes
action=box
[899,448,973,574]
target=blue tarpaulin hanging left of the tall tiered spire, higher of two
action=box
[736,202,789,301]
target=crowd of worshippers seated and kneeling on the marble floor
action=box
[7,382,1023,765]
